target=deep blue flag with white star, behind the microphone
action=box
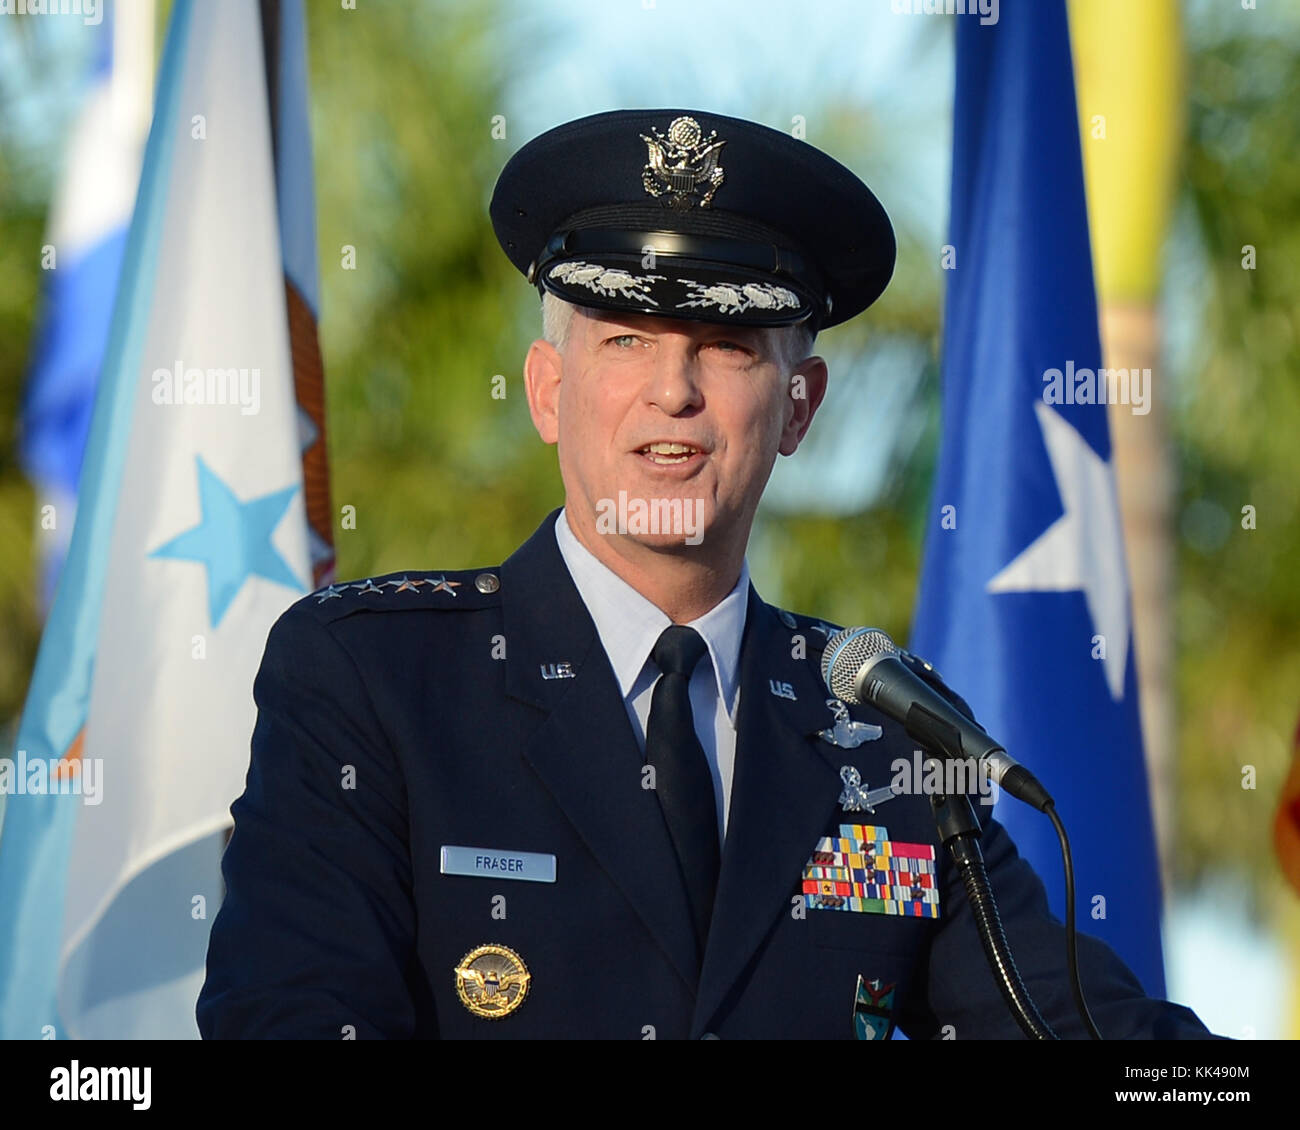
[911,0,1165,996]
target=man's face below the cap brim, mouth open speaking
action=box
[527,308,826,562]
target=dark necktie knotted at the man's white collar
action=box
[646,624,722,957]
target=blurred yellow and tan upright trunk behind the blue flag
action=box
[1069,0,1183,889]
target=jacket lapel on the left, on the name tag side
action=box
[501,510,699,991]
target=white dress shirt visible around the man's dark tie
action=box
[555,510,749,843]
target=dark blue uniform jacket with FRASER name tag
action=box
[198,514,1208,1039]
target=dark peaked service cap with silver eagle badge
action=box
[489,109,896,329]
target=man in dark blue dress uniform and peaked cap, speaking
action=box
[198,109,1209,1039]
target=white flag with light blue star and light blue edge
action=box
[0,0,328,1039]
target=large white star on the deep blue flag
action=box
[987,402,1130,702]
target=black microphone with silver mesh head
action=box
[822,628,1054,811]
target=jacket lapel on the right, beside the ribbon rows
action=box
[692,586,841,1036]
